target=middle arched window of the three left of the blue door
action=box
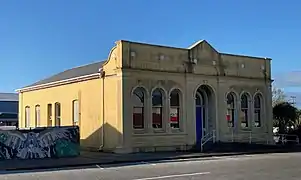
[152,89,163,129]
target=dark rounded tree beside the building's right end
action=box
[273,102,299,134]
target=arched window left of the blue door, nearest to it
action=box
[169,89,181,129]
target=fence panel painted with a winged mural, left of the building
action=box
[0,126,80,160]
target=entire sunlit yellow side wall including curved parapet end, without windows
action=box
[19,42,123,151]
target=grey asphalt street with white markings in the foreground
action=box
[0,153,301,180]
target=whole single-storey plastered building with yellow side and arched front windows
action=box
[18,40,272,153]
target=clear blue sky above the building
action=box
[0,0,301,103]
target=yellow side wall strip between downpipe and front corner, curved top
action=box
[102,43,125,152]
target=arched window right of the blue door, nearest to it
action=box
[226,92,236,127]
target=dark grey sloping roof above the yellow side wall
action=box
[23,61,105,88]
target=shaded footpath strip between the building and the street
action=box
[0,149,291,171]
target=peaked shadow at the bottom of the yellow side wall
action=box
[80,123,122,152]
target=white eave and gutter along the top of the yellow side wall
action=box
[15,72,100,93]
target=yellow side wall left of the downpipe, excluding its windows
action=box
[19,79,102,148]
